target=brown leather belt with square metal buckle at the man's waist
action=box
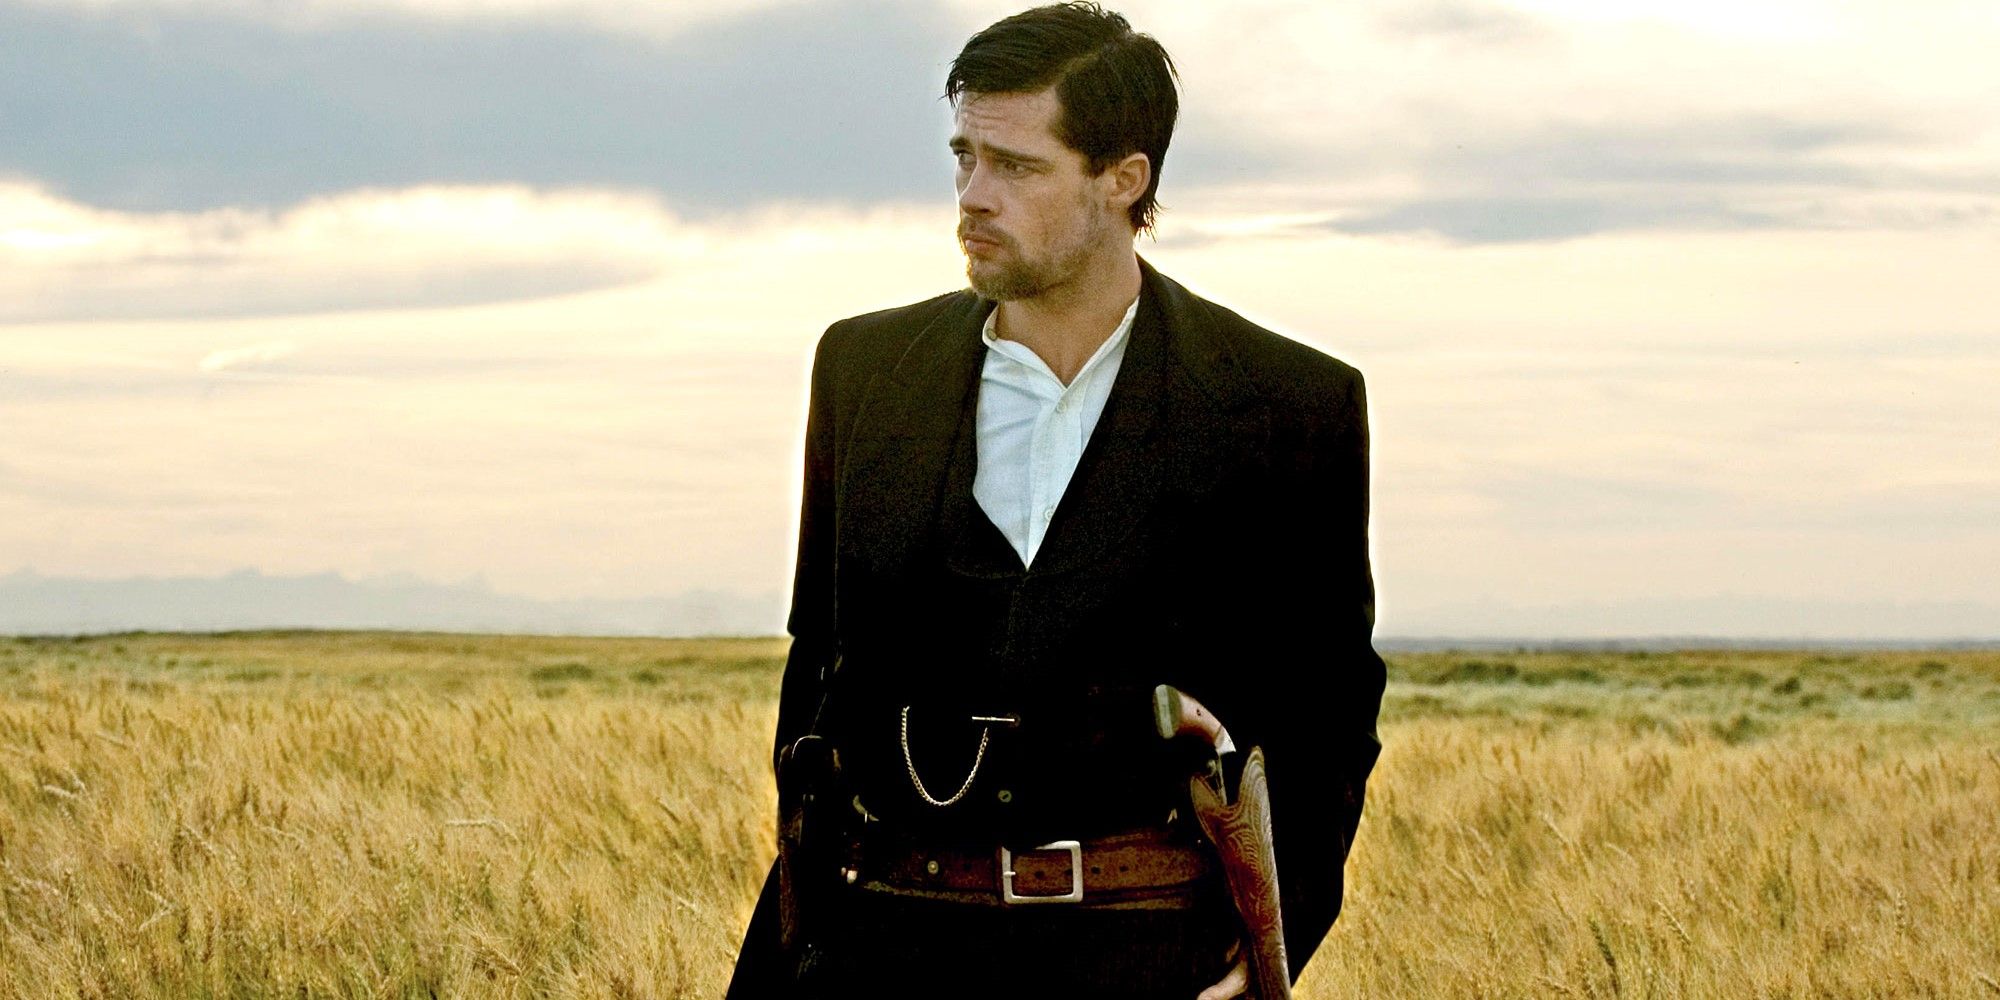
[846,828,1220,910]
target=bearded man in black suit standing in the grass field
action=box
[730,4,1382,1000]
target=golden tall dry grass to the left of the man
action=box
[0,634,782,998]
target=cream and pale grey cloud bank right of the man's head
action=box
[1162,0,2000,244]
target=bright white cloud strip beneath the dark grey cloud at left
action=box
[0,182,702,324]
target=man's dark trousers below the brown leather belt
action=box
[804,890,1238,1000]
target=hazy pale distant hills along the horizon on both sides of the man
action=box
[0,570,2000,652]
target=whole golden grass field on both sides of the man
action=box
[0,632,2000,1000]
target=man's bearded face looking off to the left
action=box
[952,88,1132,300]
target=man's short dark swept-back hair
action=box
[944,2,1180,230]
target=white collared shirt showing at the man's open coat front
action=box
[972,298,1138,566]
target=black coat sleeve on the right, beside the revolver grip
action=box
[1256,366,1384,980]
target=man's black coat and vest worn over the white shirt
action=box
[730,260,1384,996]
